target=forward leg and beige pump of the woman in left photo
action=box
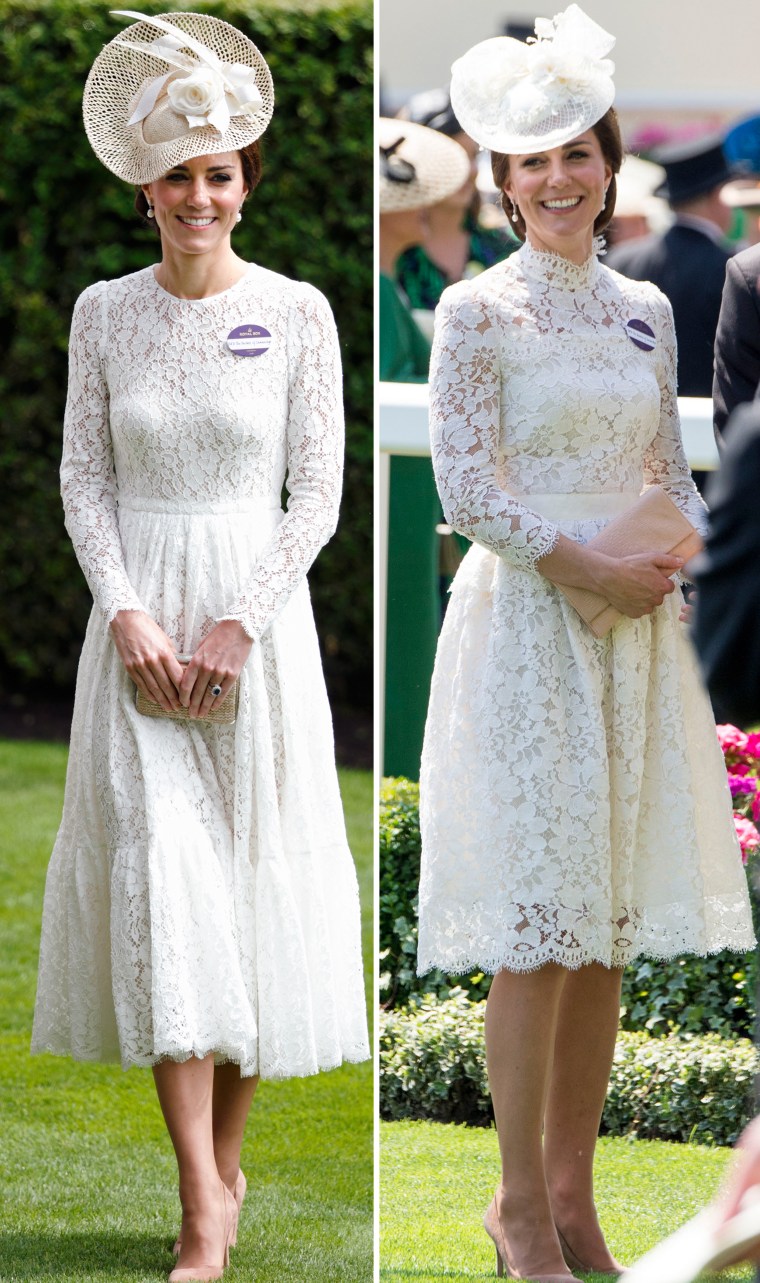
[153,1056,225,1266]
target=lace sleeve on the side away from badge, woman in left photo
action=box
[60,281,144,622]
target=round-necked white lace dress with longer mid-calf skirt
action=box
[32,266,367,1078]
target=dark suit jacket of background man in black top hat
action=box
[605,222,730,396]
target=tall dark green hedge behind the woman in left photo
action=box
[0,0,372,706]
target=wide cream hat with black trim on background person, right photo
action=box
[379,117,470,214]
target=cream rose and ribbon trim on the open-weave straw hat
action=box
[112,9,263,133]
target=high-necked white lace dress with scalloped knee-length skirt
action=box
[419,245,754,973]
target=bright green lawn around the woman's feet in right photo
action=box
[380,1123,754,1283]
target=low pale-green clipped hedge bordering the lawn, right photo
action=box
[380,989,759,1144]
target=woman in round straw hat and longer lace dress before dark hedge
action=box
[32,10,367,1283]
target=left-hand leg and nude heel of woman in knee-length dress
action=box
[485,964,567,1278]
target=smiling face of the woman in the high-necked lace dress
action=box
[503,130,612,262]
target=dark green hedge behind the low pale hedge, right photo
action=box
[380,777,757,1038]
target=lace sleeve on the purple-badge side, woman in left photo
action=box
[221,290,343,640]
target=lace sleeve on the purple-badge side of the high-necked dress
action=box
[644,295,707,535]
